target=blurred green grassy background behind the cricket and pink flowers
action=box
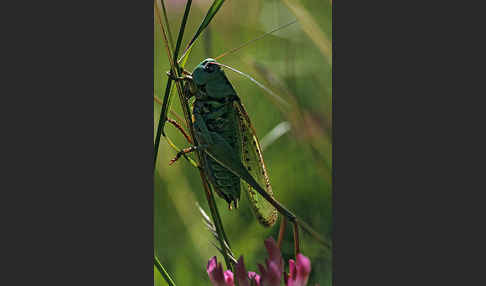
[154,0,332,286]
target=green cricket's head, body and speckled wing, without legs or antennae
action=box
[190,59,277,226]
